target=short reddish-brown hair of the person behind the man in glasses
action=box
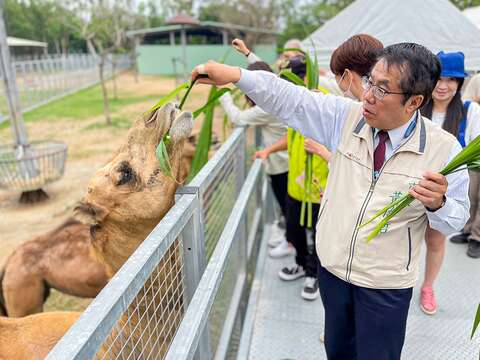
[330,34,383,76]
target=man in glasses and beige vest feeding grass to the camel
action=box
[192,43,469,360]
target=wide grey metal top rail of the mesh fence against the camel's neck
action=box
[46,195,198,360]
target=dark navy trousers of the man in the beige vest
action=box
[318,265,412,360]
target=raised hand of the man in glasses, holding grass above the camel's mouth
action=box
[192,60,241,85]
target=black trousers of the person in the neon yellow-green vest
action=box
[286,194,320,277]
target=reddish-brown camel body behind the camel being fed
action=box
[0,219,108,317]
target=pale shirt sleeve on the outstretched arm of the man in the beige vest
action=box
[236,69,352,152]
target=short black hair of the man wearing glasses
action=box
[378,43,441,106]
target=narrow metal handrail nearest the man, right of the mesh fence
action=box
[166,159,262,360]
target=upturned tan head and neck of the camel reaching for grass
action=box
[75,103,193,274]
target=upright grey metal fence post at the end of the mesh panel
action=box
[176,187,211,360]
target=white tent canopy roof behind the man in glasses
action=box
[302,0,480,70]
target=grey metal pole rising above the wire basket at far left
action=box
[0,0,28,146]
